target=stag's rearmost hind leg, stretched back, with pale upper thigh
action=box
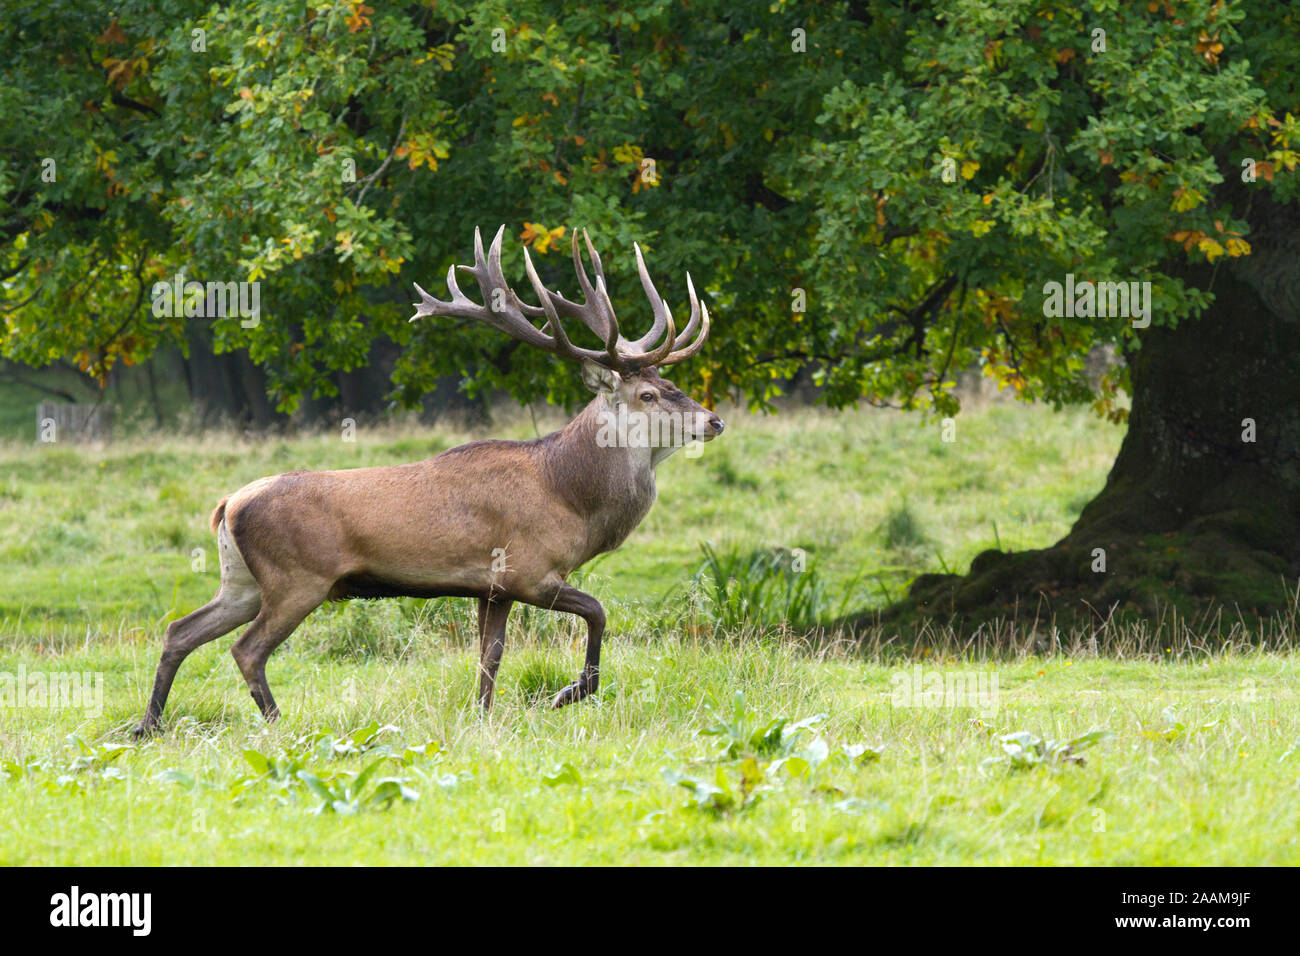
[133,523,261,737]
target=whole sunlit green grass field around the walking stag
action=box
[0,406,1300,865]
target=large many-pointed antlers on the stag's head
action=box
[411,225,709,372]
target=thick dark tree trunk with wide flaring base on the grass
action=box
[878,200,1300,623]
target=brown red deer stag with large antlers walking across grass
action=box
[134,225,725,737]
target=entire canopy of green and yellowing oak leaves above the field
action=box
[0,0,1300,416]
